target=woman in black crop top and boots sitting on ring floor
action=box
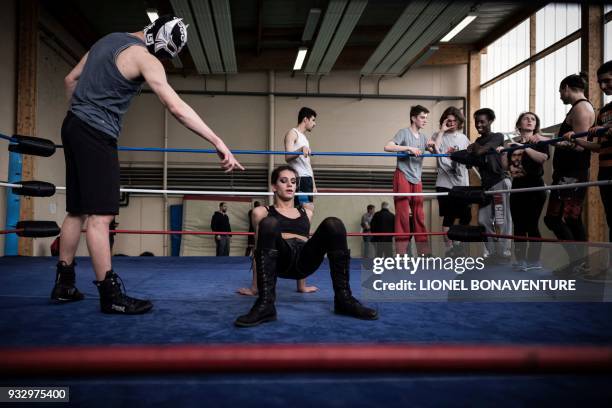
[234,165,378,327]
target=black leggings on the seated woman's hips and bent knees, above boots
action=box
[257,217,348,279]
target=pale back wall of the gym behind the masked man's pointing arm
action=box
[120,65,467,167]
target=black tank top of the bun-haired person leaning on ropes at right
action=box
[553,99,591,181]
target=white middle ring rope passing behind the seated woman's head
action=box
[0,180,612,197]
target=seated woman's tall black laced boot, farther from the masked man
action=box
[327,250,378,320]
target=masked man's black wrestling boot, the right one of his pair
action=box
[93,269,153,315]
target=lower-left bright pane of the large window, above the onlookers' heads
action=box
[480,67,529,132]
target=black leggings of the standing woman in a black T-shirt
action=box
[510,181,546,262]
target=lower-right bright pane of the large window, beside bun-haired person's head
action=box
[536,39,580,127]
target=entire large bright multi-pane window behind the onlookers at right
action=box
[480,3,588,132]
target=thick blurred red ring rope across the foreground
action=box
[0,344,612,377]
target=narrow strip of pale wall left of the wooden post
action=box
[0,0,17,256]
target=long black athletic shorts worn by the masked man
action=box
[62,112,119,215]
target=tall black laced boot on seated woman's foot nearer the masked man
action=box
[234,249,278,327]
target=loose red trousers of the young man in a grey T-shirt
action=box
[393,169,431,252]
